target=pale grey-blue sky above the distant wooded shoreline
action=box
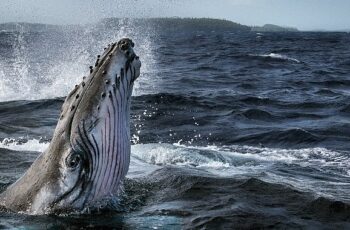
[0,0,350,30]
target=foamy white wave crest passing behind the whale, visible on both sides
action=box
[0,138,350,176]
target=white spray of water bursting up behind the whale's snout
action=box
[0,19,157,101]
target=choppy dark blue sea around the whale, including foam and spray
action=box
[0,20,350,229]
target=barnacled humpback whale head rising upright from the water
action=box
[0,38,141,215]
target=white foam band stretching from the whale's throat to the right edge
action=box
[132,143,350,176]
